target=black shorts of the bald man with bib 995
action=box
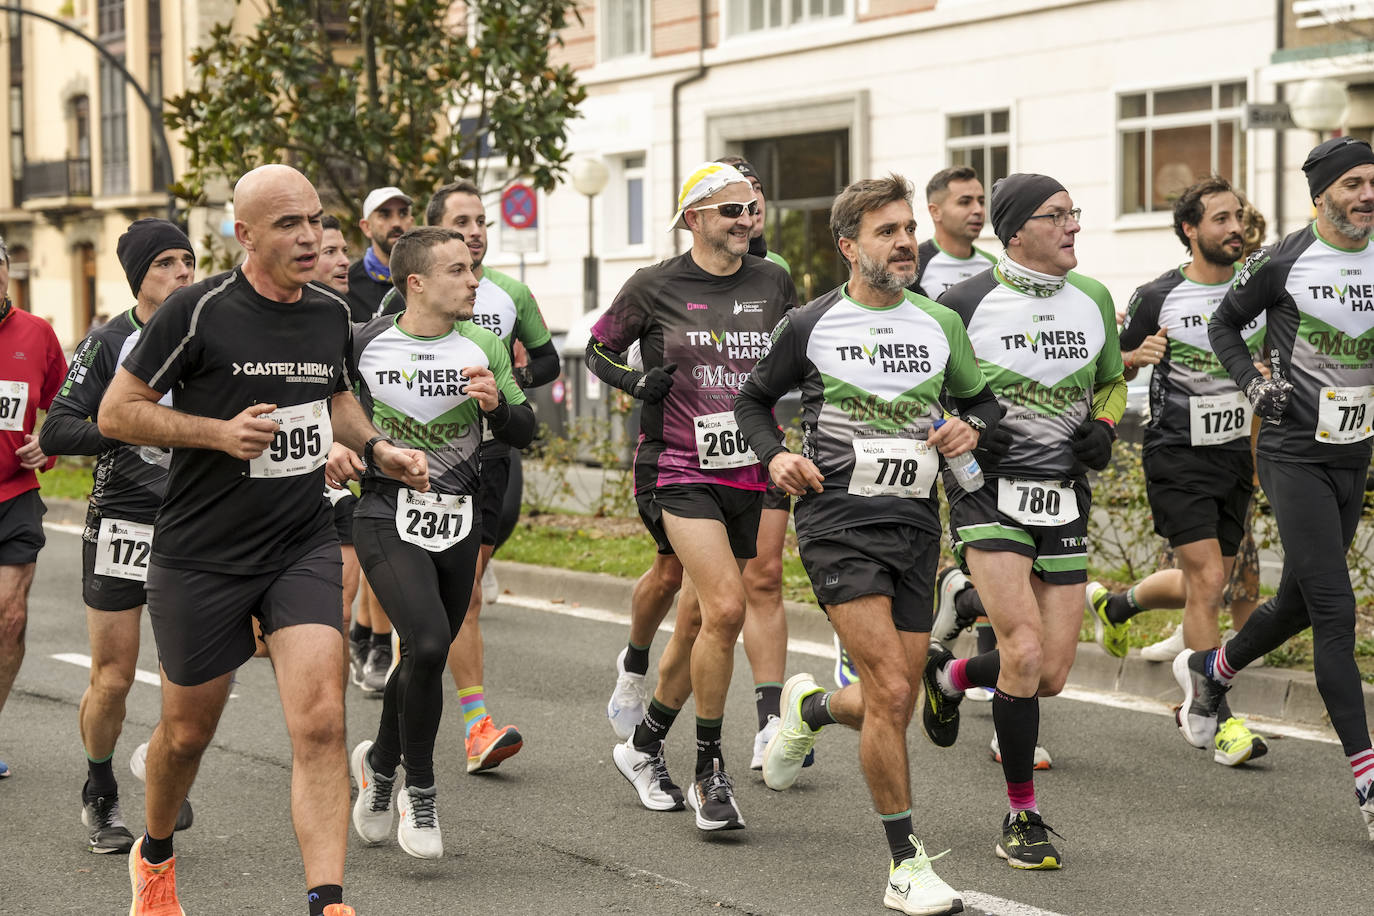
[148,538,344,687]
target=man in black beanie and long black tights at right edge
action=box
[1192,137,1374,839]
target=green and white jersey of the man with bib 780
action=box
[940,269,1121,479]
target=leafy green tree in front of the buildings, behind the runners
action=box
[165,0,585,225]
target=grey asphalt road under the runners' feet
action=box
[0,519,1374,916]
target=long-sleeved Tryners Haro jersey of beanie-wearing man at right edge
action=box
[1208,222,1374,467]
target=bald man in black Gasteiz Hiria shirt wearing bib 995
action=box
[99,165,429,916]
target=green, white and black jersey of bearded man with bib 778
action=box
[736,287,985,537]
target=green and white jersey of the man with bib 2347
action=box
[353,314,525,518]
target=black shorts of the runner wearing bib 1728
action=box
[1142,445,1254,556]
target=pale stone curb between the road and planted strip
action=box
[492,559,1374,726]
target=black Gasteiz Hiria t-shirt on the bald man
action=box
[124,269,350,574]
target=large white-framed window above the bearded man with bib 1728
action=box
[1117,81,1245,214]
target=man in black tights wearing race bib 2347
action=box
[340,227,534,858]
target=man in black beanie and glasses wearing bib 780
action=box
[922,174,1125,868]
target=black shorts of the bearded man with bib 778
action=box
[797,525,940,633]
